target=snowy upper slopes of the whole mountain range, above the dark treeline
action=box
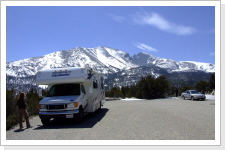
[6,47,215,77]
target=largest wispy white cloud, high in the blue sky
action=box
[133,12,196,35]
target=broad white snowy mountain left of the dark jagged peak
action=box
[6,47,137,77]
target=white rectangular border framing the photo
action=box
[1,1,221,146]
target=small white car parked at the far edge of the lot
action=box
[181,90,205,100]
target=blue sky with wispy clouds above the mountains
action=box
[6,6,215,64]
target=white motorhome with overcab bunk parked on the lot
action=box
[36,67,105,125]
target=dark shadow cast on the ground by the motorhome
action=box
[34,108,109,130]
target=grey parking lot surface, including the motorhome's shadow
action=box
[6,99,215,140]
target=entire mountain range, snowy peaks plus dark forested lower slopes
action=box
[6,47,215,91]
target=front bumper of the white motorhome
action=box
[39,110,79,119]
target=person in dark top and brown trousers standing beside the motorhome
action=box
[16,92,32,130]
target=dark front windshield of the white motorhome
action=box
[47,84,80,97]
